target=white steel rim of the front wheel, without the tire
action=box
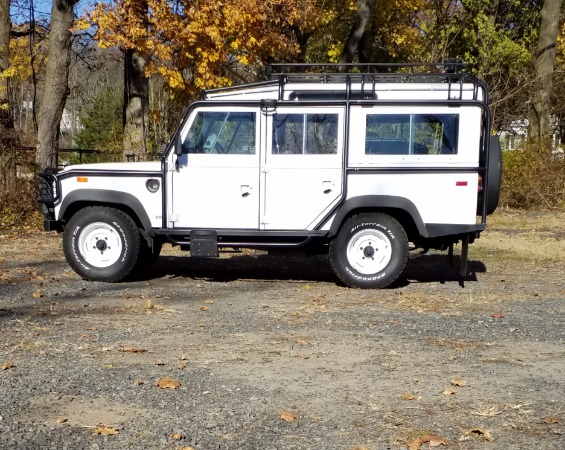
[78,222,123,268]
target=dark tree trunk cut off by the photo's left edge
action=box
[0,0,17,194]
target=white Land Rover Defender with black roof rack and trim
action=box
[39,63,501,288]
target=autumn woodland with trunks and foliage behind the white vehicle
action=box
[0,0,565,228]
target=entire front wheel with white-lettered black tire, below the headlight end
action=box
[63,206,140,282]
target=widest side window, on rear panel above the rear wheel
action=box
[365,114,459,155]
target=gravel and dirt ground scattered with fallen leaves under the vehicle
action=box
[0,211,565,450]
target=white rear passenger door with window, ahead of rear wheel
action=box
[260,107,344,230]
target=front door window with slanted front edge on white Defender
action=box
[183,111,255,155]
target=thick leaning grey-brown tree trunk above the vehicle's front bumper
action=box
[35,0,78,169]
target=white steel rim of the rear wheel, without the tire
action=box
[347,229,392,275]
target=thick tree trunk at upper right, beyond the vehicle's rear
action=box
[529,0,562,140]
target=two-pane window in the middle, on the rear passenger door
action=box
[273,114,338,155]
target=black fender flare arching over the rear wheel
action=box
[329,195,430,237]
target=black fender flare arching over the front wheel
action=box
[59,189,155,236]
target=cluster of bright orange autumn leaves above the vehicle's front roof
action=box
[85,0,316,93]
